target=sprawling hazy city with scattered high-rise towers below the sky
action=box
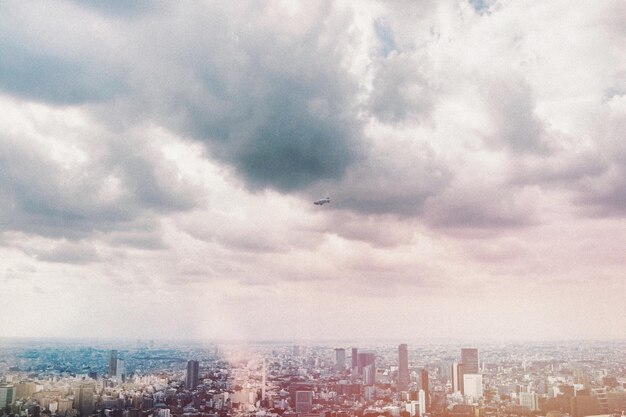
[0,340,626,417]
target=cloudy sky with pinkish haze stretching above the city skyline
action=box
[0,0,626,340]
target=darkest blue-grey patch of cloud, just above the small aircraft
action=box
[210,71,359,191]
